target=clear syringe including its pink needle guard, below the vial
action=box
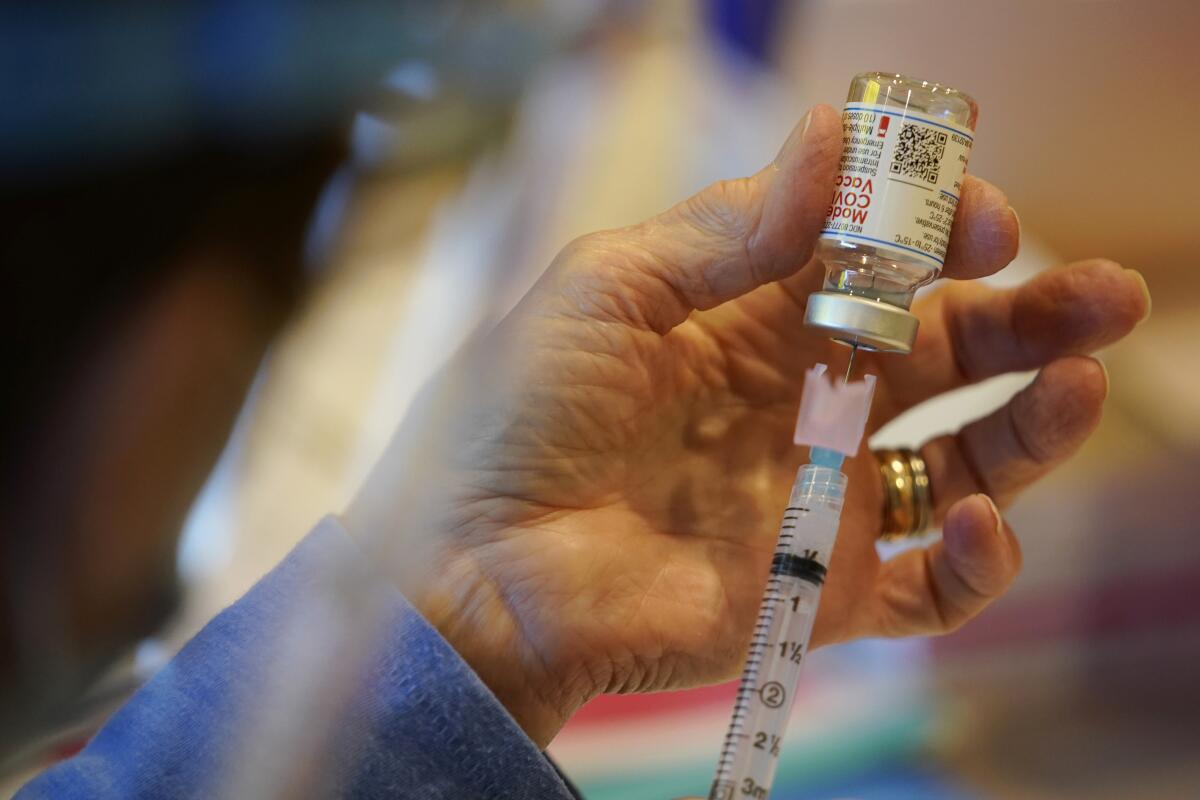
[708,356,875,800]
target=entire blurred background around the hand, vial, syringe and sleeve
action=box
[0,0,1200,800]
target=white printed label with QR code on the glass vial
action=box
[821,103,974,269]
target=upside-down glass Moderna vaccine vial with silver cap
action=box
[804,72,978,353]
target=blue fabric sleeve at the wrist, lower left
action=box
[17,518,572,800]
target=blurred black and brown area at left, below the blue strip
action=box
[0,137,344,753]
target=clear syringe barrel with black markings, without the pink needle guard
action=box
[708,447,846,800]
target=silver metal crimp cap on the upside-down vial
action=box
[804,291,919,353]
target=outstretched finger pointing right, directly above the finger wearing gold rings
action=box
[876,259,1150,420]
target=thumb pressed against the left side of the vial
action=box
[549,106,842,333]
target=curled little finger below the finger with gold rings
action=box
[874,494,1021,636]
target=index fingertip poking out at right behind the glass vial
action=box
[942,175,1021,279]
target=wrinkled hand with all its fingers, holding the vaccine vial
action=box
[352,107,1148,745]
